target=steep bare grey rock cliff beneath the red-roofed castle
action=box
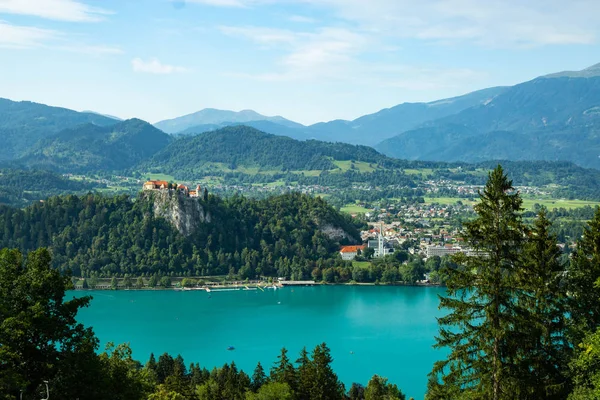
[142,190,211,236]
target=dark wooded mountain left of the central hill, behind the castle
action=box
[19,119,172,173]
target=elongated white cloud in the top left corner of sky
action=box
[0,0,111,22]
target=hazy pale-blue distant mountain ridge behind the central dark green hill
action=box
[154,108,304,133]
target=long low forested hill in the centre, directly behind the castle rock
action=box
[140,126,386,174]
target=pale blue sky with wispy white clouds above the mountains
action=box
[0,0,600,124]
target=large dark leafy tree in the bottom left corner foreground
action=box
[0,249,98,399]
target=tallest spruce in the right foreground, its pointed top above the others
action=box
[429,166,525,400]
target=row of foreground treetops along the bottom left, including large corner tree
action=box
[0,249,405,400]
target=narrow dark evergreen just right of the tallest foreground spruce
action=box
[509,208,571,400]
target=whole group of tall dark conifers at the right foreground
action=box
[427,166,600,400]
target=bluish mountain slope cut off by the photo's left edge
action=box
[0,98,115,160]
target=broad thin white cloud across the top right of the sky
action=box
[308,0,600,47]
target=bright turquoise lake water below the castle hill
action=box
[69,286,443,399]
